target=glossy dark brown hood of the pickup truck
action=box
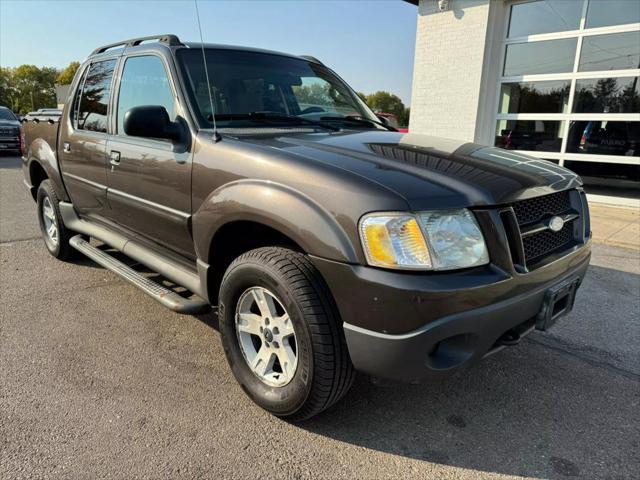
[231,131,582,210]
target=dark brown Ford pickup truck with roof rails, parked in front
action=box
[23,35,591,419]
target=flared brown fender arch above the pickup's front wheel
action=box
[192,179,358,263]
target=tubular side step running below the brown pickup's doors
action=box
[69,235,209,314]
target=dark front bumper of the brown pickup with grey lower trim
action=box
[312,244,591,382]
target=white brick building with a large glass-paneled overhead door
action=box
[406,0,640,205]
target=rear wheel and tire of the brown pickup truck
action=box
[36,180,76,260]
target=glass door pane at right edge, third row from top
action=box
[573,77,640,113]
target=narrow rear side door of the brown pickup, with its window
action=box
[58,58,117,217]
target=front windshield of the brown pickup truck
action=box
[178,49,380,128]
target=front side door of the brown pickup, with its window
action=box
[107,54,193,256]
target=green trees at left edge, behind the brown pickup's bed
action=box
[0,62,80,115]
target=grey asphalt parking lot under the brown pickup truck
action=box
[0,156,640,479]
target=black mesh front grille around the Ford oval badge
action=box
[511,190,581,270]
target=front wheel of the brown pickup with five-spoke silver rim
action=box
[218,247,355,421]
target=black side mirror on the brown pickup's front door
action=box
[124,105,181,141]
